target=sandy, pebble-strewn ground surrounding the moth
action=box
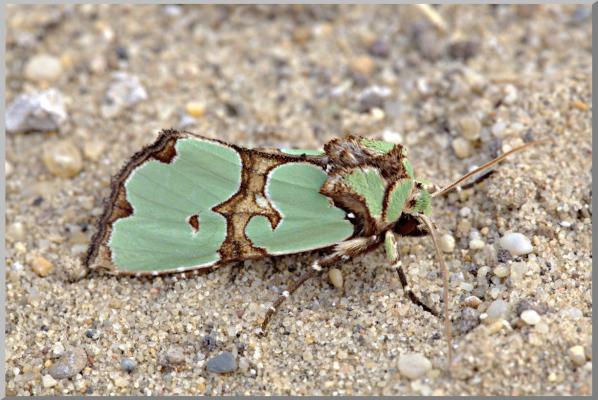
[6,5,592,395]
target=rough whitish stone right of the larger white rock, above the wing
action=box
[100,72,148,118]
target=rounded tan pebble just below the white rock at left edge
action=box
[42,140,83,178]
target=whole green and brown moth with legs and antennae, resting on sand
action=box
[85,130,548,362]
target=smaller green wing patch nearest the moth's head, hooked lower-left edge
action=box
[245,163,353,254]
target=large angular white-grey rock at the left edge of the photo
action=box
[6,89,67,133]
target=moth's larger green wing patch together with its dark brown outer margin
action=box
[86,131,242,274]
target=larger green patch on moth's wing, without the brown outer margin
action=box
[109,139,241,272]
